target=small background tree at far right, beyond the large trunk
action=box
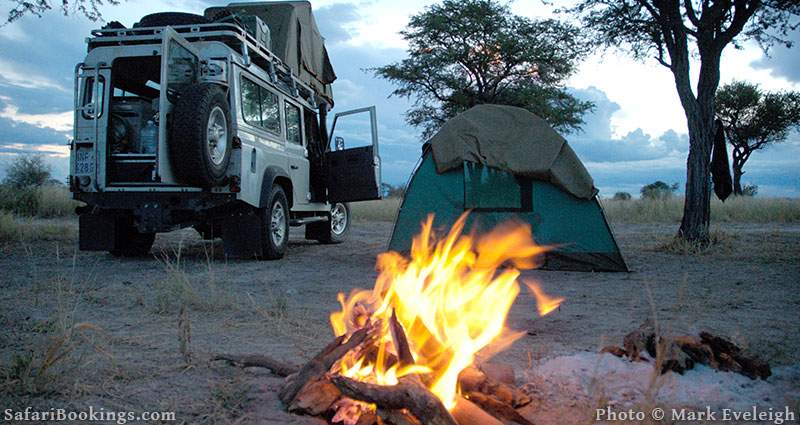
[716,81,800,195]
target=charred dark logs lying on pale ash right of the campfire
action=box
[600,327,772,379]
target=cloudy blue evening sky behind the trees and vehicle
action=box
[0,0,800,197]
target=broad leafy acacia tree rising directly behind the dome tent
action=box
[373,0,592,138]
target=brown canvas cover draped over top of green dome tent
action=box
[430,105,597,199]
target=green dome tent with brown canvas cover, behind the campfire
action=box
[389,105,628,271]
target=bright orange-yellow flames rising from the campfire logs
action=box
[330,213,546,408]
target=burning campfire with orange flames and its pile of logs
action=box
[216,214,563,425]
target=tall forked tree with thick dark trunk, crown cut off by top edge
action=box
[567,0,800,244]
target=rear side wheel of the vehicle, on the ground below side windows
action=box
[259,185,289,260]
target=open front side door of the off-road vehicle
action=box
[325,106,381,202]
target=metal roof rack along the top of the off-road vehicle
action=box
[86,23,333,109]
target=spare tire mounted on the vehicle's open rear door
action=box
[169,83,233,187]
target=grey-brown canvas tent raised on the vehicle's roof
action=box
[205,1,336,98]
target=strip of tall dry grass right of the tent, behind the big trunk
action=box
[602,197,800,223]
